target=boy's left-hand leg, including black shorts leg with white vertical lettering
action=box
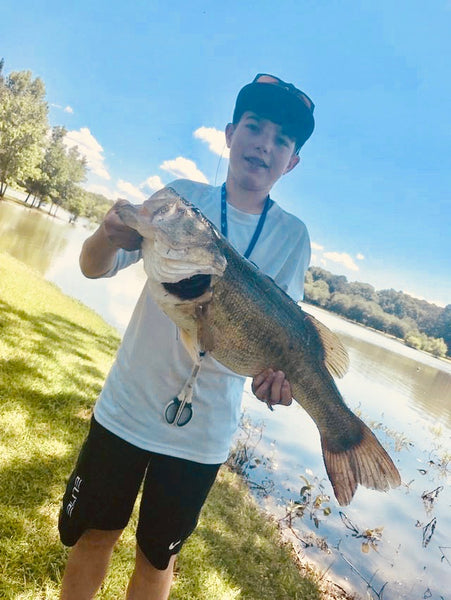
[59,419,150,600]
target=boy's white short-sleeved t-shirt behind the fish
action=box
[94,180,310,464]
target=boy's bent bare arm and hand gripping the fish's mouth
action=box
[80,200,142,279]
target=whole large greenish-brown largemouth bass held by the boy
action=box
[117,188,401,505]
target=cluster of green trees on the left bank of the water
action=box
[0,60,113,222]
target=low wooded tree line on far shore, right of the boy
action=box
[305,267,451,357]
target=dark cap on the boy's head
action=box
[233,74,315,152]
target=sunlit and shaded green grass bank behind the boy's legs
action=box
[0,253,320,600]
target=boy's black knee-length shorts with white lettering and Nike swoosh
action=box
[58,418,220,569]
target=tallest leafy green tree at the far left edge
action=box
[0,65,48,198]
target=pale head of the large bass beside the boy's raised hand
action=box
[119,188,227,283]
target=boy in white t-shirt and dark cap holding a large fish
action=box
[59,74,314,600]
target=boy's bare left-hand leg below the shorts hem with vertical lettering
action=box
[60,529,123,600]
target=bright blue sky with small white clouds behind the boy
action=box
[0,0,451,304]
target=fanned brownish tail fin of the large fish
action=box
[321,419,401,506]
